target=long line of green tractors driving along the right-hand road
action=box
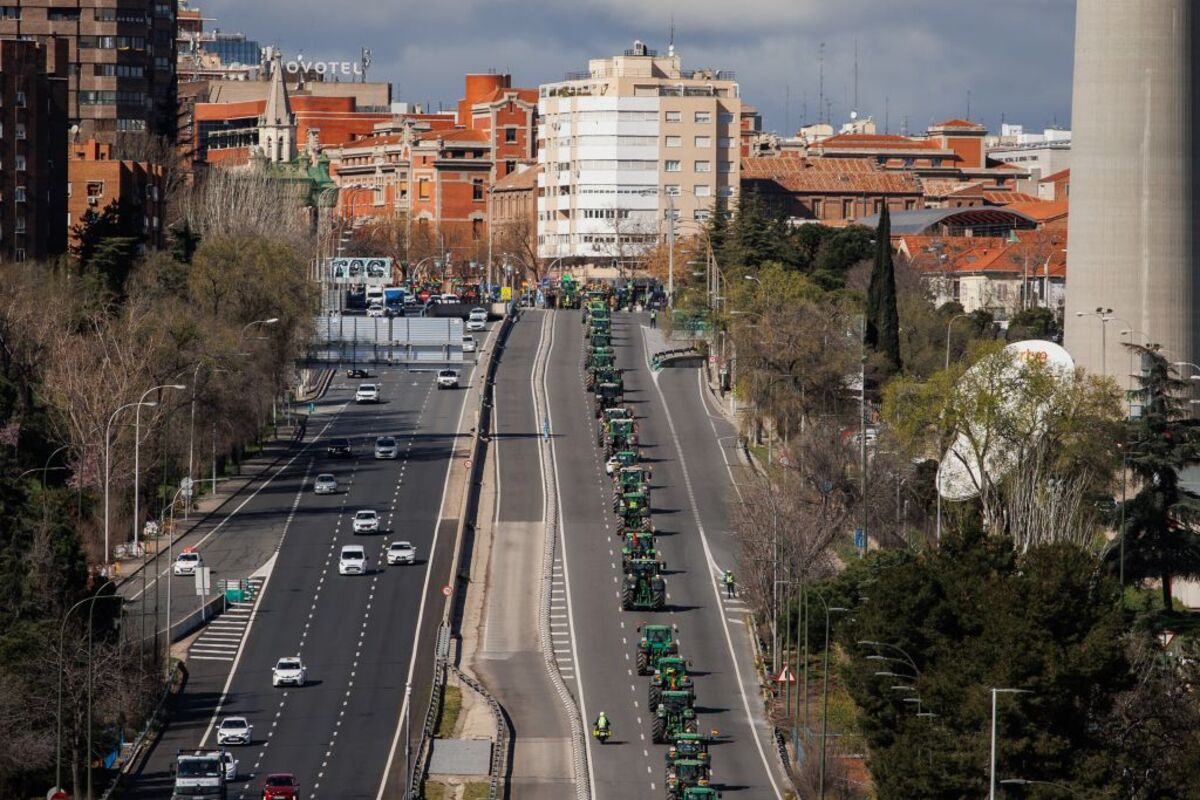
[583,298,720,800]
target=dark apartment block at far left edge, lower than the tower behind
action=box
[0,38,67,263]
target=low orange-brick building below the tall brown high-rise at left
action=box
[67,139,166,247]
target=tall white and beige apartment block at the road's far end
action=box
[538,42,743,261]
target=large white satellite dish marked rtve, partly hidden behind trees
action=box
[936,339,1075,503]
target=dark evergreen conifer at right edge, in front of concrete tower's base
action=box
[1109,344,1200,610]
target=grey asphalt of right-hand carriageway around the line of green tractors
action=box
[542,313,781,799]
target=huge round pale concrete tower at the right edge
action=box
[1066,0,1200,386]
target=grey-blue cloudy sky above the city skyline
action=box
[191,0,1075,133]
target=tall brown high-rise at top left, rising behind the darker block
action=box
[0,0,175,143]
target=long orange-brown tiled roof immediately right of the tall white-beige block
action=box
[742,157,920,194]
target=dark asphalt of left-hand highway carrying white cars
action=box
[133,335,484,800]
